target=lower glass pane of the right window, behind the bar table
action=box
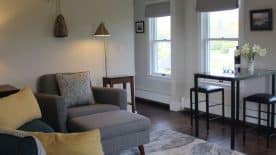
[208,41,238,73]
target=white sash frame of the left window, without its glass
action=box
[149,16,171,79]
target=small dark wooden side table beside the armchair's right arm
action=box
[103,76,136,113]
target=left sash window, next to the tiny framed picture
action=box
[149,16,171,77]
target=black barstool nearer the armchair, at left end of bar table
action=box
[190,85,225,131]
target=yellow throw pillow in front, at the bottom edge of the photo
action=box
[29,129,104,155]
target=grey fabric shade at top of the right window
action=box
[196,0,239,12]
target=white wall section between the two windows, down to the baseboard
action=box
[171,0,200,111]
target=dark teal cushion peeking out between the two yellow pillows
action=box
[18,119,54,133]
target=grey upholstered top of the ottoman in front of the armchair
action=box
[68,111,150,140]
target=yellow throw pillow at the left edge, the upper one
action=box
[0,88,41,129]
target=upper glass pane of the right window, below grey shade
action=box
[209,9,239,38]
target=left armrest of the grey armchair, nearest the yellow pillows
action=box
[36,93,68,132]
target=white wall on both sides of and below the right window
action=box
[171,0,276,125]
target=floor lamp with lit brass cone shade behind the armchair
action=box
[94,22,110,77]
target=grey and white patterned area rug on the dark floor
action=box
[120,130,244,155]
